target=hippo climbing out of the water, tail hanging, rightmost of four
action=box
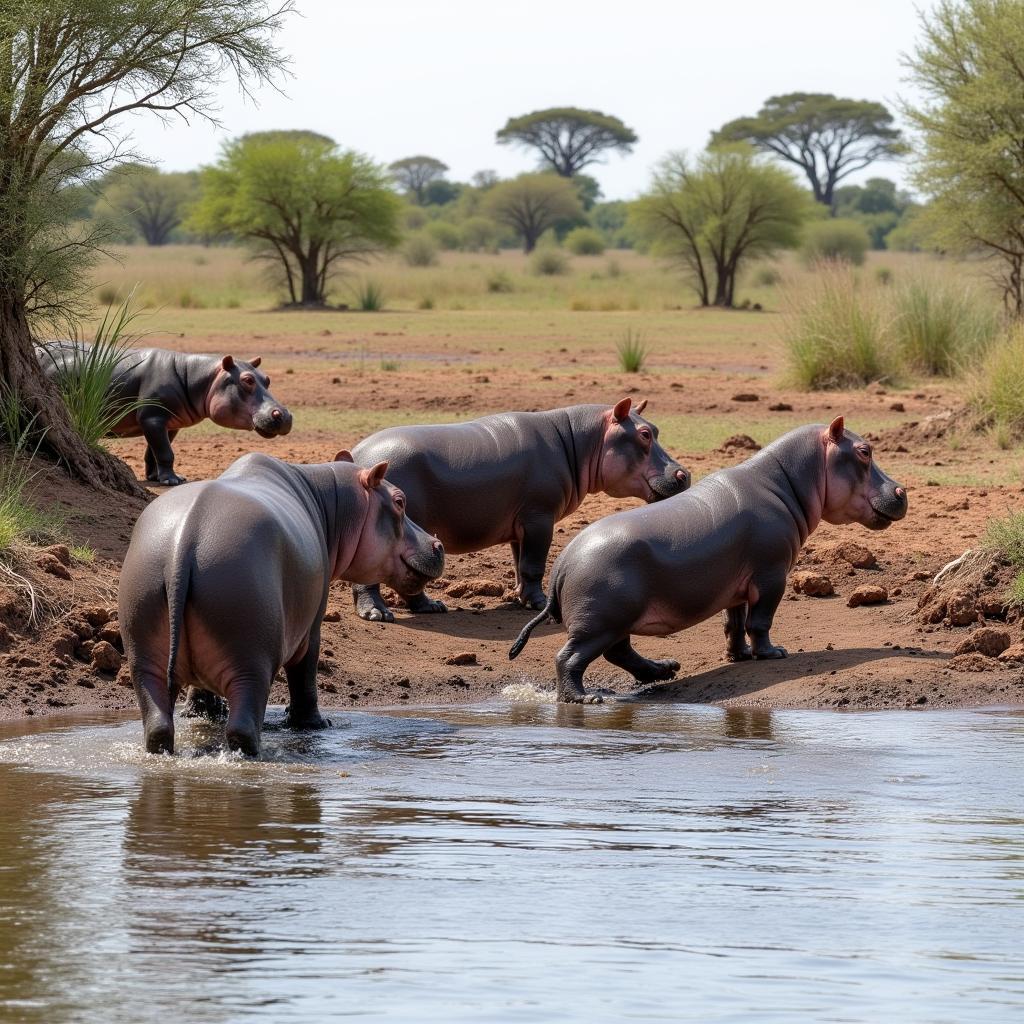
[509,416,907,703]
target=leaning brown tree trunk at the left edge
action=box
[0,296,148,498]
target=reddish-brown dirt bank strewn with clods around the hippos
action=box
[0,323,1024,718]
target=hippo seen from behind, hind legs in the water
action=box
[118,452,444,756]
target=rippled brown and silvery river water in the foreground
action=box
[0,703,1024,1024]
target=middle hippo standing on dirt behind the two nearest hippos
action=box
[352,398,690,622]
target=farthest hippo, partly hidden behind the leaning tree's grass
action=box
[36,341,292,486]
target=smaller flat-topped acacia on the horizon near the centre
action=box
[498,106,637,178]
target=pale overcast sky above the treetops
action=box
[125,0,927,199]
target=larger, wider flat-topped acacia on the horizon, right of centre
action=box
[711,92,906,209]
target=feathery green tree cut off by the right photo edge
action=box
[904,0,1024,316]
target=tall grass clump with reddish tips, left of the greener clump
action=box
[784,264,897,390]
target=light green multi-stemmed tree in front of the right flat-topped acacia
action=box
[632,146,813,307]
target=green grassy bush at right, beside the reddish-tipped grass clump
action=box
[893,280,999,377]
